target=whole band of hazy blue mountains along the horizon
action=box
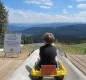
[8,23,86,35]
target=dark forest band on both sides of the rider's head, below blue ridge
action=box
[22,35,86,44]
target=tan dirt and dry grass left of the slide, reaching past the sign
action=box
[0,44,39,80]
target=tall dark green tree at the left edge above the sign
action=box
[0,1,8,37]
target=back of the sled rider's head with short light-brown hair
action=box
[43,33,55,44]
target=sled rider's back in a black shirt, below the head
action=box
[40,44,57,64]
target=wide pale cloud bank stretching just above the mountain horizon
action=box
[6,7,86,23]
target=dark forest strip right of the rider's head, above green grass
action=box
[56,35,86,44]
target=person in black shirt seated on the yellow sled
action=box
[39,33,57,68]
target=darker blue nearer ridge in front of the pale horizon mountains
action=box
[21,24,86,37]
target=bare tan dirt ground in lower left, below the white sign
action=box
[0,52,28,80]
